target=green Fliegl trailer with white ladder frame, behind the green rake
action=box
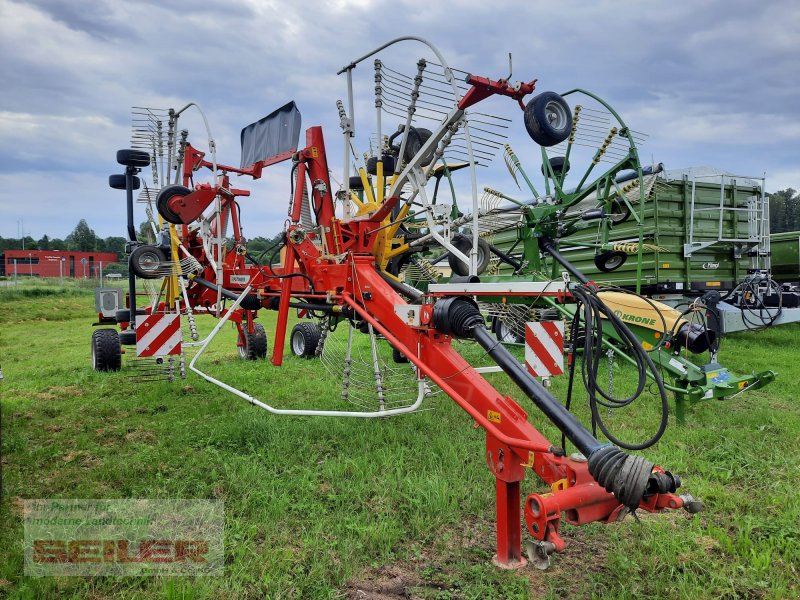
[478,168,772,296]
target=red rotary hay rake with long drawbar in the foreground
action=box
[101,38,700,568]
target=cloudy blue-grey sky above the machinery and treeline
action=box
[0,0,800,239]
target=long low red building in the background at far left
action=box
[0,250,117,279]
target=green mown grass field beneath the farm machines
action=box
[0,285,800,599]
